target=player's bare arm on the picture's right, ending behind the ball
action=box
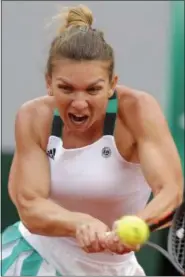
[122,93,183,224]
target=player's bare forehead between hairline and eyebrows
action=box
[53,59,108,84]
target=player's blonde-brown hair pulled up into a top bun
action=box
[46,5,114,80]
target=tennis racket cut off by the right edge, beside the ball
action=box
[144,202,185,276]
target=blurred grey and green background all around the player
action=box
[1,1,184,276]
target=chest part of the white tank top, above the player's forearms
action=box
[48,135,151,227]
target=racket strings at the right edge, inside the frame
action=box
[172,211,185,272]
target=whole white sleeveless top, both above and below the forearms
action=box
[20,135,151,276]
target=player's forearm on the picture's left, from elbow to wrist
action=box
[18,198,90,237]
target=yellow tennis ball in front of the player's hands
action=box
[116,216,150,246]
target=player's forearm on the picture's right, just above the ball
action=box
[138,188,182,228]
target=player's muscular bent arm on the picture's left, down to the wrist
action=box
[8,104,92,236]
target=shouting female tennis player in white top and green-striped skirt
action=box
[2,5,183,276]
